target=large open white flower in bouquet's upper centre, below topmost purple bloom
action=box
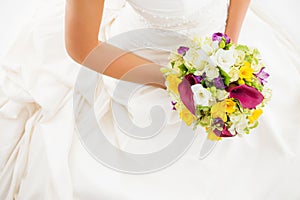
[211,49,235,73]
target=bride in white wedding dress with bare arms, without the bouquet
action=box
[0,0,300,200]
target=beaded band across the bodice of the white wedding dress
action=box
[127,0,228,31]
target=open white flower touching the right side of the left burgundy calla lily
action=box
[191,84,212,106]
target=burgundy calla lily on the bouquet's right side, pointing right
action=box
[229,84,264,109]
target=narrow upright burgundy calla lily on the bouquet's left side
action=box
[178,78,196,115]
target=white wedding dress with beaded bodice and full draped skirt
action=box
[0,0,300,200]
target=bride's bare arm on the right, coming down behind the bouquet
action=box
[225,0,250,43]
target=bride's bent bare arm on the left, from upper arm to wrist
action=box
[65,0,165,88]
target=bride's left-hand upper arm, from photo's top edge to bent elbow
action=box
[65,0,104,63]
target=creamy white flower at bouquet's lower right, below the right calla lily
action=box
[229,114,248,134]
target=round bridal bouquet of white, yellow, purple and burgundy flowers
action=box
[161,33,271,140]
